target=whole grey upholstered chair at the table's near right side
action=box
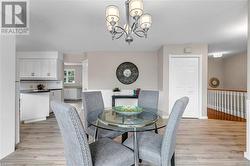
[123,97,189,166]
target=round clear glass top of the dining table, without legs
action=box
[88,109,167,132]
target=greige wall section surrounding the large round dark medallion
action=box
[87,52,158,89]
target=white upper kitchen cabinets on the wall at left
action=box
[17,52,63,80]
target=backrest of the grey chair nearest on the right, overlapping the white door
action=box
[161,97,189,166]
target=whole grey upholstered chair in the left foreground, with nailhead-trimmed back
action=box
[51,102,134,166]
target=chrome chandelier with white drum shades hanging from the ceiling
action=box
[106,0,152,44]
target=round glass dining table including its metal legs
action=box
[88,107,167,166]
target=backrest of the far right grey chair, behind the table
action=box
[138,90,159,110]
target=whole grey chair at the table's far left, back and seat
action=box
[82,91,122,138]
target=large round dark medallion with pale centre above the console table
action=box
[116,62,139,85]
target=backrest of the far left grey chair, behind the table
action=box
[82,91,104,128]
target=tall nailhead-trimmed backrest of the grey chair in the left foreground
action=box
[51,102,92,166]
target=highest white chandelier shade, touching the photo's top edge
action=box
[129,0,143,17]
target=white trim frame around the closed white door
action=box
[168,54,203,119]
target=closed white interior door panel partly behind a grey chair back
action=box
[169,56,201,118]
